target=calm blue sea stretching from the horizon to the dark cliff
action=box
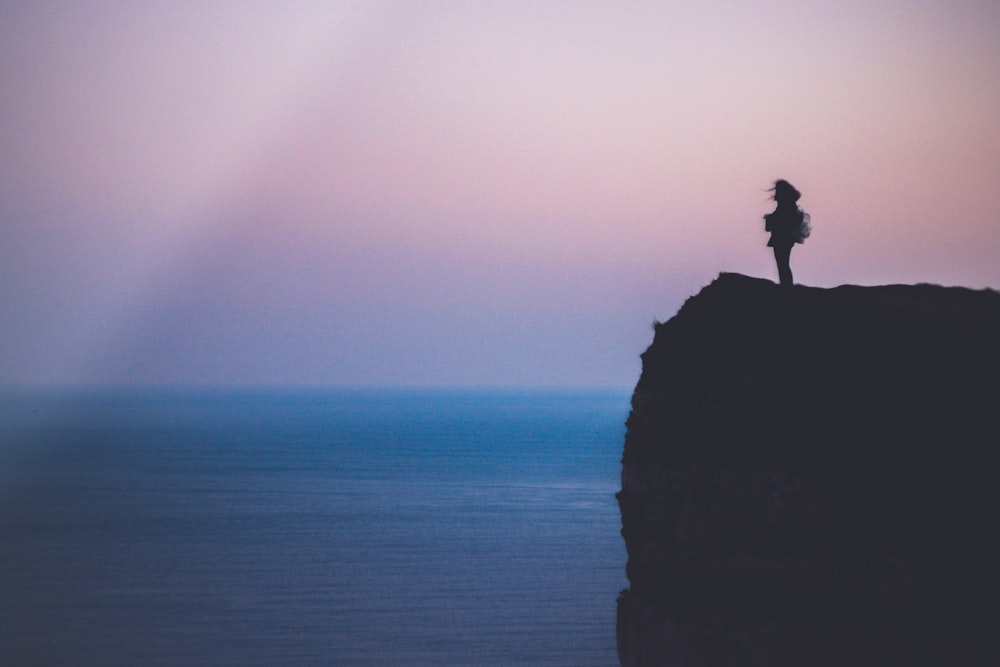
[0,390,628,667]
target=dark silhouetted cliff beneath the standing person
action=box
[618,274,1000,667]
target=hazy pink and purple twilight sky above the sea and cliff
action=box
[0,0,1000,387]
